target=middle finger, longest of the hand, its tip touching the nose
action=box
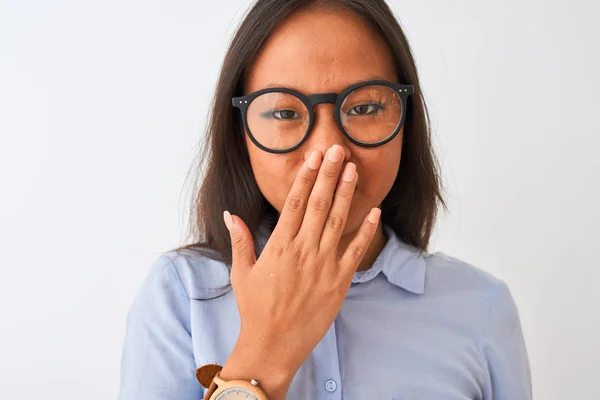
[298,145,344,246]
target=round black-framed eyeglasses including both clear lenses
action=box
[231,80,414,154]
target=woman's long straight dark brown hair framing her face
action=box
[169,0,447,265]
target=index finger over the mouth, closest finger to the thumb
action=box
[273,150,322,240]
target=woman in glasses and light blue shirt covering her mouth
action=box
[120,0,531,400]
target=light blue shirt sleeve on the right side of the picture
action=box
[481,282,532,400]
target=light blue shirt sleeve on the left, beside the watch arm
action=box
[119,255,204,400]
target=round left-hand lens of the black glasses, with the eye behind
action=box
[246,92,309,150]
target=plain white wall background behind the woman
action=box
[0,0,600,400]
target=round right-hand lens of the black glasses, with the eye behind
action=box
[340,85,402,143]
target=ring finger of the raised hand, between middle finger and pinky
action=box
[319,163,358,249]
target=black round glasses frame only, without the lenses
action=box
[231,80,415,154]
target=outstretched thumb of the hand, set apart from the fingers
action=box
[223,210,256,276]
